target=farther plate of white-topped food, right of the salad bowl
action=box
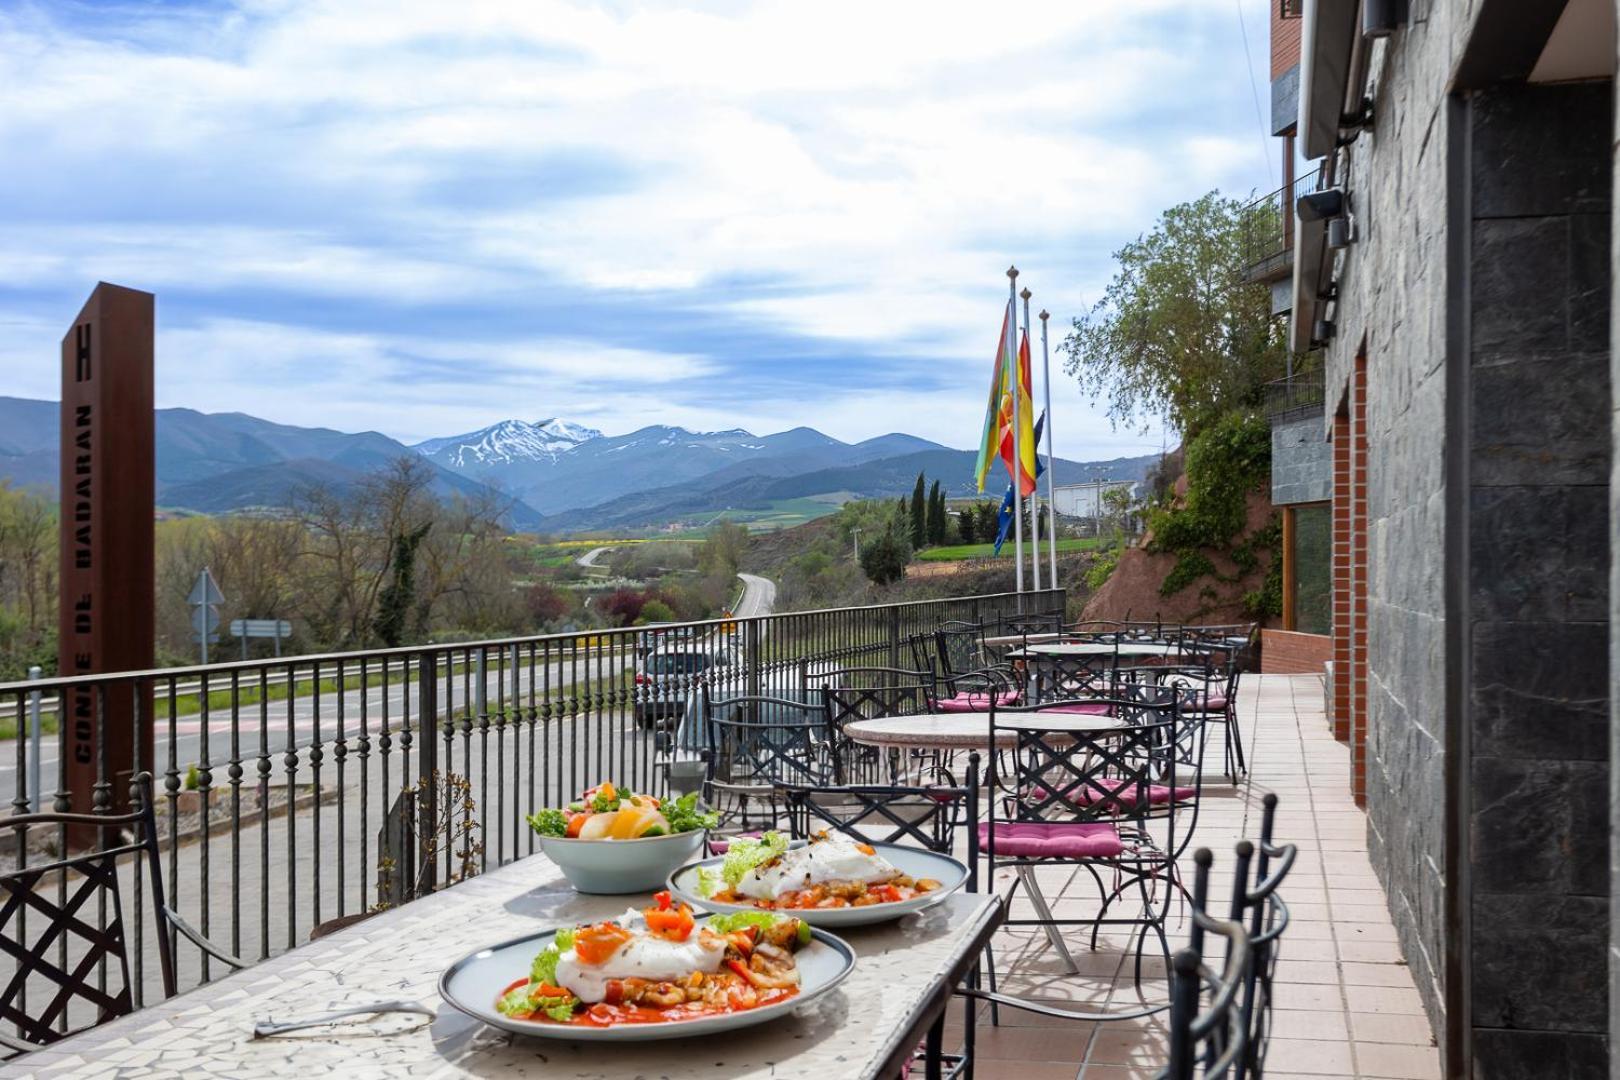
[669,832,967,926]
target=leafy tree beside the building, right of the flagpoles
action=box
[1059,191,1286,437]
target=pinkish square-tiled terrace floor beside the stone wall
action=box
[953,675,1442,1080]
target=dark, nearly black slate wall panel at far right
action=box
[1469,83,1614,1077]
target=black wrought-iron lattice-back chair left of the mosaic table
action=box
[0,772,248,1056]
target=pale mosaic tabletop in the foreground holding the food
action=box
[0,855,1000,1080]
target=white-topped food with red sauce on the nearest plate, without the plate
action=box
[496,892,812,1028]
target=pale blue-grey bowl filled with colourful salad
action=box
[528,780,716,894]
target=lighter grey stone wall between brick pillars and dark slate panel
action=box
[1324,12,1477,1031]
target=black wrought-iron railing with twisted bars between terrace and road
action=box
[0,589,1064,1002]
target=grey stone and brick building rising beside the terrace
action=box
[1254,0,1620,1080]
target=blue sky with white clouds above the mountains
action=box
[0,0,1278,458]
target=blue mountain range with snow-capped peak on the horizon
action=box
[0,397,1155,533]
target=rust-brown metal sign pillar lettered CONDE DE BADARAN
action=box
[58,282,156,816]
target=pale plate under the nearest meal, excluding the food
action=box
[439,918,855,1043]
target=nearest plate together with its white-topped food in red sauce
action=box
[439,892,855,1043]
